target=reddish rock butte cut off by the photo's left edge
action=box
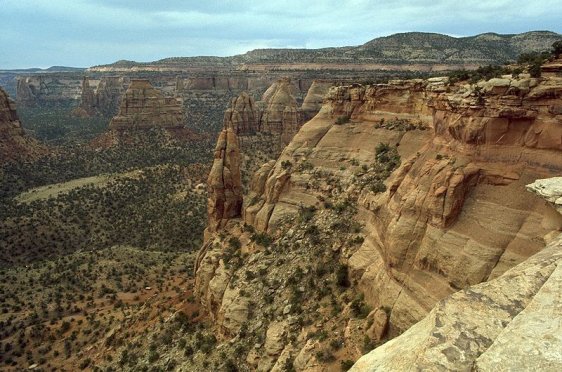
[0,88,47,164]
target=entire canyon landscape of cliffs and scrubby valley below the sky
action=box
[0,32,562,372]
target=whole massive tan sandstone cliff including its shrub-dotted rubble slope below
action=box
[196,72,562,371]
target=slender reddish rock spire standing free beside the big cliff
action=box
[207,127,242,233]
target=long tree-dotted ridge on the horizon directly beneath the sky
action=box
[91,31,562,69]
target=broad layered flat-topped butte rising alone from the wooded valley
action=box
[109,79,183,130]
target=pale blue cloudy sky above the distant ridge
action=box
[0,0,562,69]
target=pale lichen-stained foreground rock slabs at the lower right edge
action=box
[351,177,562,371]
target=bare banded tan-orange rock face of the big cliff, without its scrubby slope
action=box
[240,78,562,335]
